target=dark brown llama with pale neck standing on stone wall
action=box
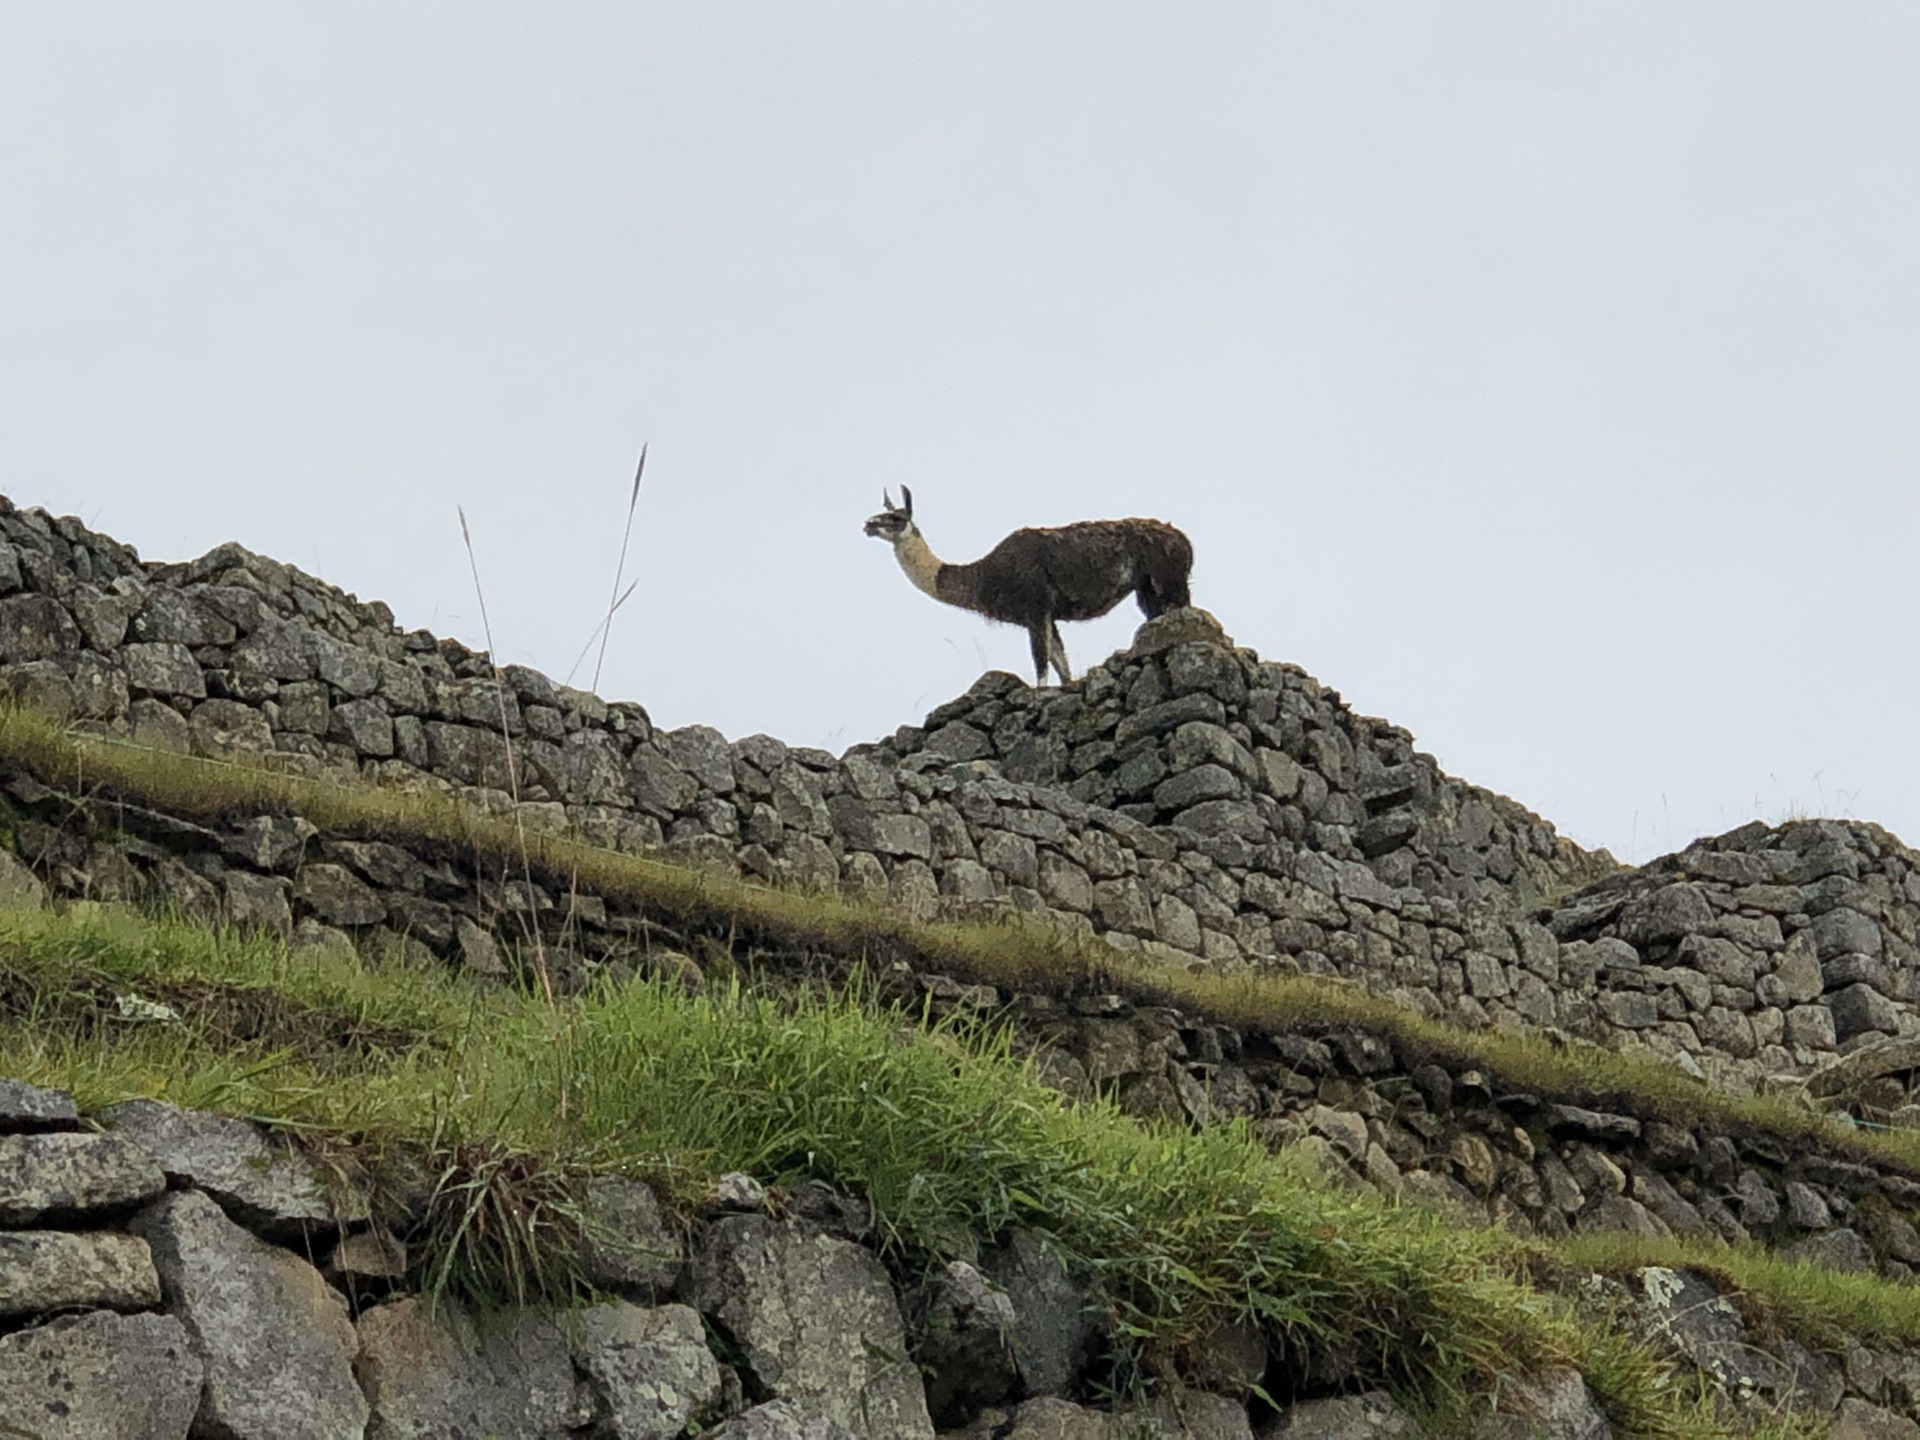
[866,486,1194,685]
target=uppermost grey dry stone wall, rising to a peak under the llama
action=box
[0,501,1920,1087]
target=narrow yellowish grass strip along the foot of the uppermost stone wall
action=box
[0,708,1920,1198]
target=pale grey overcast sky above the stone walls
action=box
[0,0,1920,858]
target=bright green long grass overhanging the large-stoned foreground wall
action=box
[0,906,1758,1436]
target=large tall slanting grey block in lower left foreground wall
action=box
[132,1190,367,1440]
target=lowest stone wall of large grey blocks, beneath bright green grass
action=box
[0,1081,1651,1440]
